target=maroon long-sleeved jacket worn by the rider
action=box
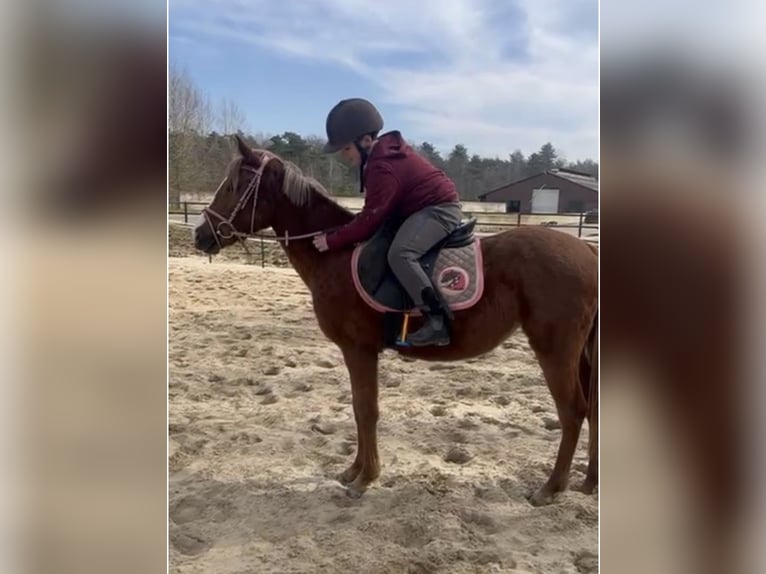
[327,131,460,249]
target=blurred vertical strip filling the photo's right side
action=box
[601,2,766,574]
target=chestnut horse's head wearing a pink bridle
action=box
[194,136,280,254]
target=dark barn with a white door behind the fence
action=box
[479,169,598,213]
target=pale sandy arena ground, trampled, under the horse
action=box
[169,230,598,574]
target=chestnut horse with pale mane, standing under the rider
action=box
[194,138,598,505]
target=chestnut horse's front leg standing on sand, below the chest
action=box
[340,347,380,498]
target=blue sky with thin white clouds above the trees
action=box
[169,0,598,160]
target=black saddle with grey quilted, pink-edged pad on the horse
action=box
[351,218,484,324]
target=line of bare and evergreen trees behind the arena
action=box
[168,66,598,205]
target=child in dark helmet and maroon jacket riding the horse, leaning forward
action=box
[314,98,462,346]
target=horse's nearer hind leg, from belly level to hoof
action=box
[530,339,587,506]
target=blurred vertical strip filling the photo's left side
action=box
[0,1,167,574]
